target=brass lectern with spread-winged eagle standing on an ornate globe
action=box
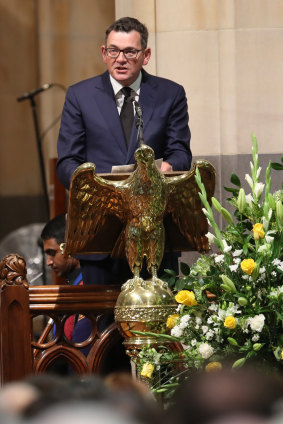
[64,144,215,345]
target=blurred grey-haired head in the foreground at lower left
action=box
[8,374,160,424]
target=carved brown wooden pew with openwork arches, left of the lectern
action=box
[0,254,122,384]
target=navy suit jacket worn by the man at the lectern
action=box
[57,70,191,188]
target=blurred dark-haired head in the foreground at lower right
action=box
[164,367,283,424]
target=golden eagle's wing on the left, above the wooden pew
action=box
[64,162,127,255]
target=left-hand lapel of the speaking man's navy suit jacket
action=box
[94,72,127,156]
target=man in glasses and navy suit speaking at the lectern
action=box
[57,18,191,283]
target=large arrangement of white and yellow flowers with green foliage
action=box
[139,135,283,398]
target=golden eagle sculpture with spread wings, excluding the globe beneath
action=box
[64,144,215,277]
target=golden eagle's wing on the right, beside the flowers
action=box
[166,160,215,252]
